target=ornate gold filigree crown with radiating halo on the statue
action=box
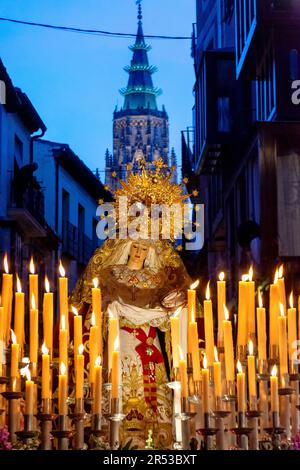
[104,158,190,241]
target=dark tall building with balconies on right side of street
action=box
[182,0,300,295]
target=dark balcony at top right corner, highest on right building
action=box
[235,0,300,78]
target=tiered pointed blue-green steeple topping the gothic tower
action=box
[120,3,161,110]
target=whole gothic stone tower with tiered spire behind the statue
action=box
[105,4,169,189]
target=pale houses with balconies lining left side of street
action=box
[0,57,111,304]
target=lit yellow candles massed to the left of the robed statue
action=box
[0,256,120,414]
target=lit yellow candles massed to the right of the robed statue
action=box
[171,267,300,411]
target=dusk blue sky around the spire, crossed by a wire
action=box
[0,0,195,179]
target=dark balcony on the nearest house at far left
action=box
[7,178,47,238]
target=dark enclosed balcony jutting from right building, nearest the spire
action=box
[195,50,236,174]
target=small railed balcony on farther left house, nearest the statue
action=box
[62,221,95,264]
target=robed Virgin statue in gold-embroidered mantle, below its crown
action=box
[70,160,202,449]
